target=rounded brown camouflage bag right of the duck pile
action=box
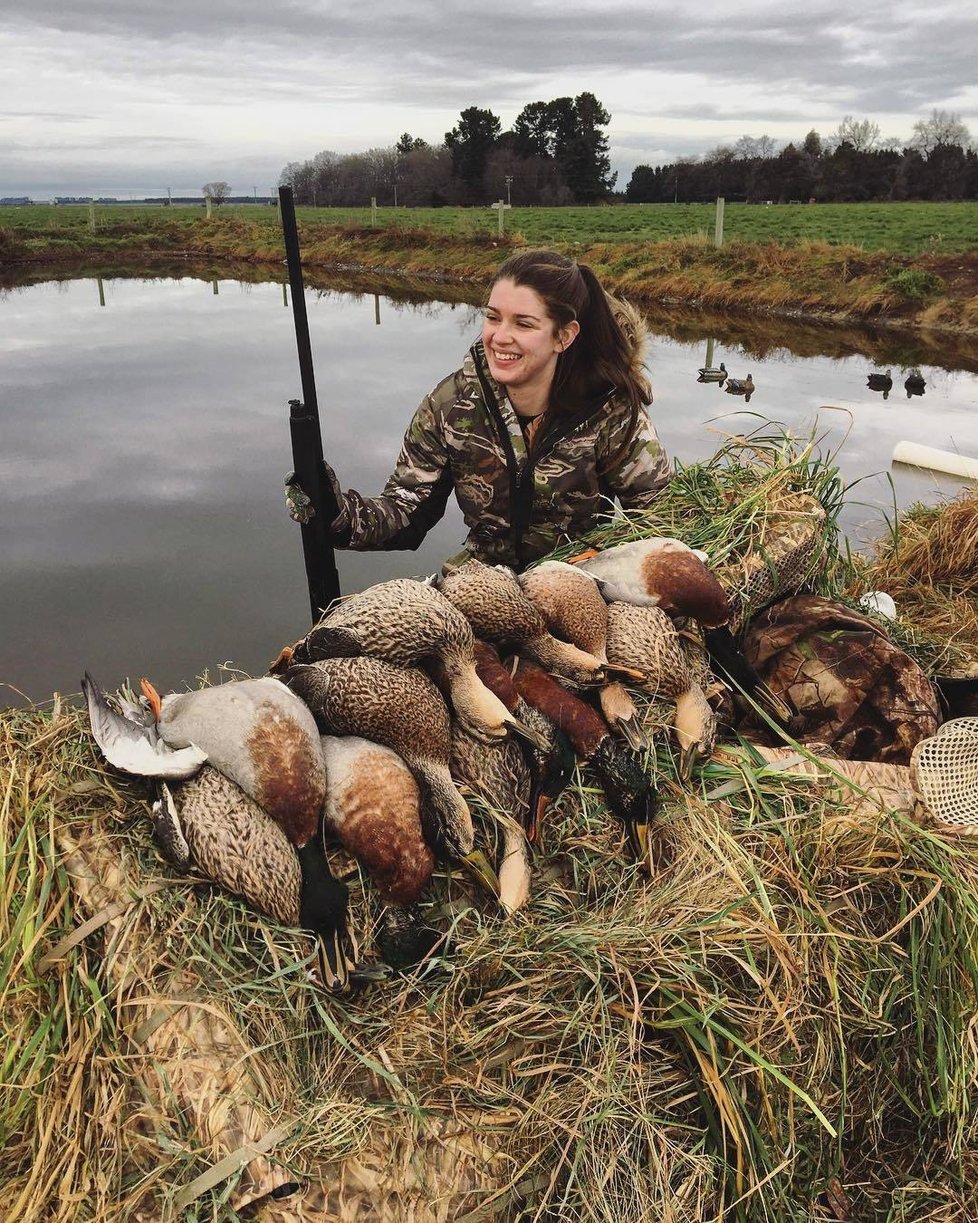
[743,594,941,764]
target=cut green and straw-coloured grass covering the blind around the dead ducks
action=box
[0,437,978,1223]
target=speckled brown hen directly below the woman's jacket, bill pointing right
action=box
[438,560,605,686]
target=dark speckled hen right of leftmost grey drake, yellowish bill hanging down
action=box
[281,656,499,896]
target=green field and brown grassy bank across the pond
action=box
[0,204,978,335]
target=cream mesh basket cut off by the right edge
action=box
[910,718,978,833]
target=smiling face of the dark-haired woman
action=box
[482,280,579,407]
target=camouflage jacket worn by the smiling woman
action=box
[333,340,671,570]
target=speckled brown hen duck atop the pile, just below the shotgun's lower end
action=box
[273,577,537,740]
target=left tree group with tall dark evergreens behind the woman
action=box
[279,93,616,208]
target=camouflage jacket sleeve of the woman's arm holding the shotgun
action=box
[331,388,454,552]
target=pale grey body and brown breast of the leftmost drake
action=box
[137,678,326,848]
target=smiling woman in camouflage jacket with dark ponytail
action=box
[305,251,670,571]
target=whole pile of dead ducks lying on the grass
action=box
[82,538,789,989]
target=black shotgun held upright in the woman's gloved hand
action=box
[279,187,340,624]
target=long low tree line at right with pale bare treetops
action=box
[623,110,978,203]
